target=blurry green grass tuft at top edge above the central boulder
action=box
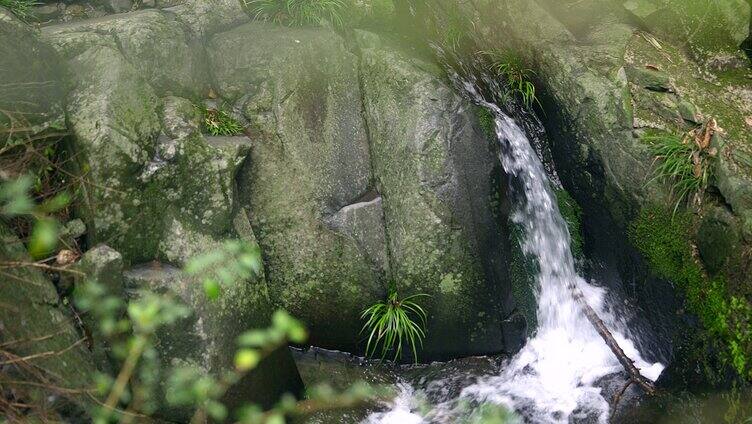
[243,0,347,27]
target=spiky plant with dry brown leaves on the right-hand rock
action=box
[643,119,718,211]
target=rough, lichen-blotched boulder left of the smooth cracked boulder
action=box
[49,30,248,264]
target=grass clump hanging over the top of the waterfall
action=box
[481,51,540,108]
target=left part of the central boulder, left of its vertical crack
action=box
[209,23,386,351]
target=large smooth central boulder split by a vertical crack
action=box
[208,23,511,359]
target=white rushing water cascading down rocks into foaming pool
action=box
[368,74,664,424]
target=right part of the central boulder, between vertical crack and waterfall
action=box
[357,32,520,358]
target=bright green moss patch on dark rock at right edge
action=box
[629,207,752,379]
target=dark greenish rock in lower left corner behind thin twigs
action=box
[0,222,97,416]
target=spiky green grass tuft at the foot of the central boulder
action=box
[361,289,428,363]
